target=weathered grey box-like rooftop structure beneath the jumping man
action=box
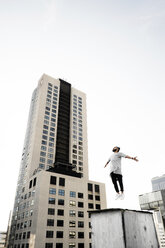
[91,209,159,248]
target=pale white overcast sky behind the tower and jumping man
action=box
[0,0,165,231]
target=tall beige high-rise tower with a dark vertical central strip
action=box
[7,74,106,248]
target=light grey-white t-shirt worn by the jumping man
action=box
[108,152,127,175]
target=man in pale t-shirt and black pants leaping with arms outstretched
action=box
[104,146,139,200]
